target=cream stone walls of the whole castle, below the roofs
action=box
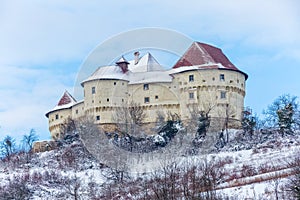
[49,69,245,139]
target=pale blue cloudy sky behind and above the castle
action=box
[0,0,300,140]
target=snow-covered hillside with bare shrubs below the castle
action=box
[0,130,300,200]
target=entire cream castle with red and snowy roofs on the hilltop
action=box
[46,42,248,139]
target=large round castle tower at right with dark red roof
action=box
[170,42,248,127]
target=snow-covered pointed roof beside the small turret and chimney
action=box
[128,53,165,73]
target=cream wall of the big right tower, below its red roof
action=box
[173,69,245,125]
